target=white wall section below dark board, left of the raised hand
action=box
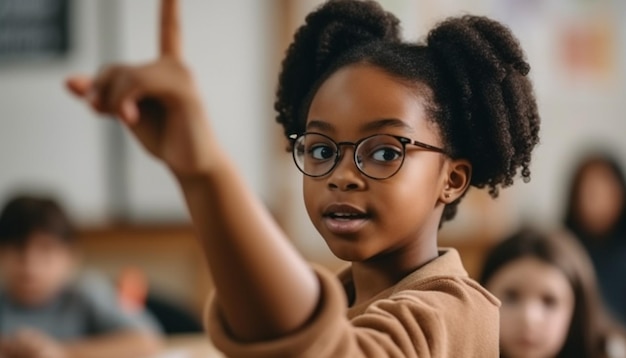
[0,0,107,220]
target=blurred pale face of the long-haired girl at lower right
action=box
[486,257,575,358]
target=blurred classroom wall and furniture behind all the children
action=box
[0,0,626,346]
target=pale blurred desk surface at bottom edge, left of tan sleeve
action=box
[155,334,224,358]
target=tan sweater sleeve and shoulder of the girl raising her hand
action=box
[206,267,498,358]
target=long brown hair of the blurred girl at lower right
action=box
[480,228,623,358]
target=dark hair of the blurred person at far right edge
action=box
[564,152,626,240]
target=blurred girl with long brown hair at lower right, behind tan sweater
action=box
[481,229,626,358]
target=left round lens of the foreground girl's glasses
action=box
[293,133,337,176]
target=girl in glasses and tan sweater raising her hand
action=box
[68,0,539,358]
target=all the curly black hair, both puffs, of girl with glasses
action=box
[275,0,539,222]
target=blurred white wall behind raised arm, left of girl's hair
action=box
[0,0,274,223]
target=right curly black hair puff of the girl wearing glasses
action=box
[427,15,539,195]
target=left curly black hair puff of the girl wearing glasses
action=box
[274,0,400,135]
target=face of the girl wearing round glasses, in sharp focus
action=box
[303,64,449,261]
